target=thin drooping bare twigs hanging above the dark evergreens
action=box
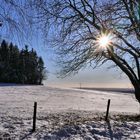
[0,0,33,39]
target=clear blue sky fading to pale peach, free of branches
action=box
[1,24,132,88]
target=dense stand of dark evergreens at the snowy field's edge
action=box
[0,40,46,85]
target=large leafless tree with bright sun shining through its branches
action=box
[35,0,140,102]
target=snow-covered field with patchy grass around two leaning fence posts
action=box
[0,85,140,140]
